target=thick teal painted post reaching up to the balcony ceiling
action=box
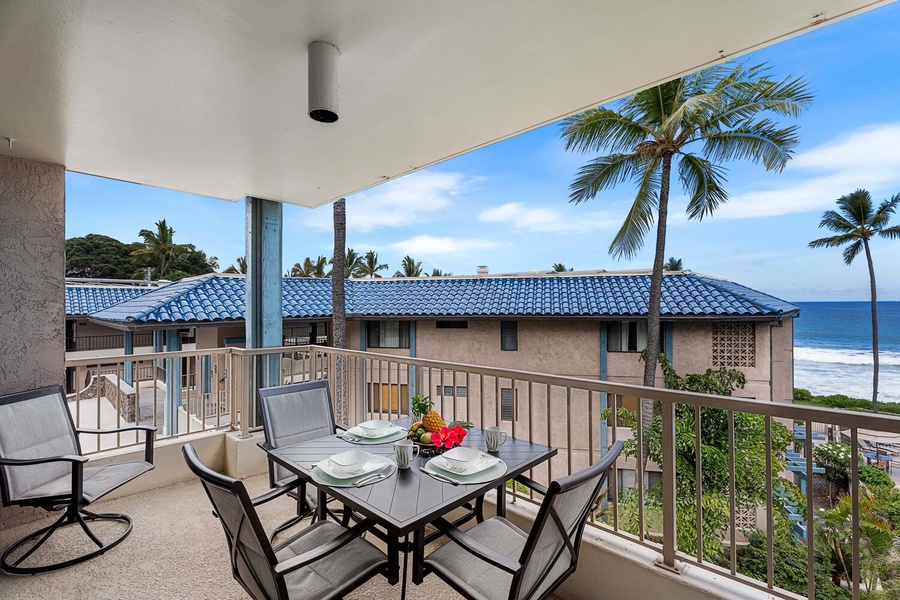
[245,196,284,425]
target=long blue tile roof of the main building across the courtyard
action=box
[91,273,799,324]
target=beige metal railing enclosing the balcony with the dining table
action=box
[66,346,900,598]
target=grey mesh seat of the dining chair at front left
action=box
[275,521,384,600]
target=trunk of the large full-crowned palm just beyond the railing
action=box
[641,156,672,450]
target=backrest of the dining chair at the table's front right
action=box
[509,441,624,600]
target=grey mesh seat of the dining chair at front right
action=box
[426,517,528,600]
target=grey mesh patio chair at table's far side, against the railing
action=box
[259,380,350,540]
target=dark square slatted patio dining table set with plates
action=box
[268,418,556,596]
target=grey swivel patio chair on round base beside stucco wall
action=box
[0,385,156,575]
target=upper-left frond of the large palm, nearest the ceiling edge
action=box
[560,108,654,152]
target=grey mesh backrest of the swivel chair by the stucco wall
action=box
[0,385,81,505]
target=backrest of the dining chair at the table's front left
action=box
[181,444,287,600]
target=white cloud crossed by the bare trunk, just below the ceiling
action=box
[304,171,470,232]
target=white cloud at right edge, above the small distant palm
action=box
[715,123,900,220]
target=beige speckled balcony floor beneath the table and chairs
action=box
[0,475,564,600]
